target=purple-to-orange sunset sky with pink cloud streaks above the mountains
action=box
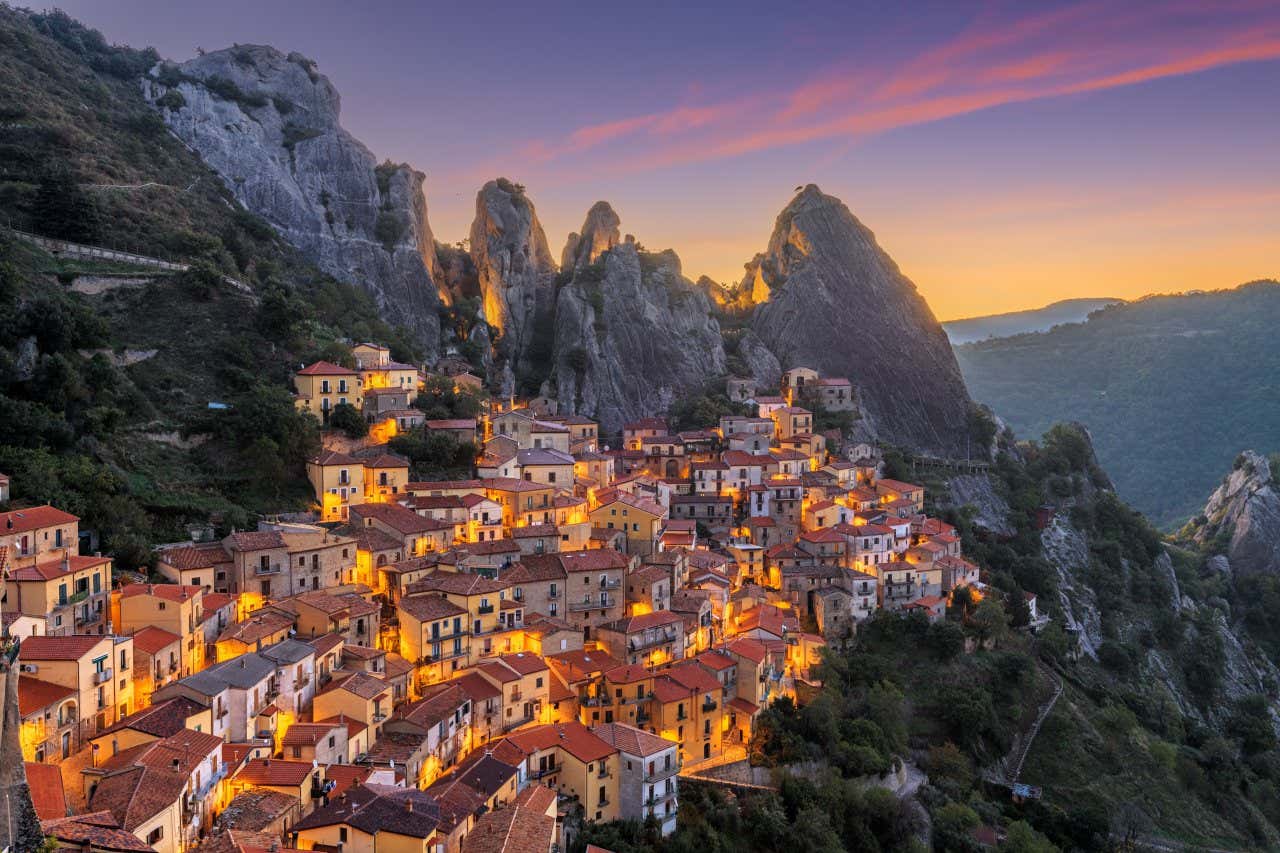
[47,0,1280,319]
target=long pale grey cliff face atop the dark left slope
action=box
[142,45,440,352]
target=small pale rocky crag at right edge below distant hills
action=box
[1193,451,1280,574]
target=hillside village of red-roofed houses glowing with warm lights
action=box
[0,343,1034,853]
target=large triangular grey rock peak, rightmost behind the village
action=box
[744,184,969,456]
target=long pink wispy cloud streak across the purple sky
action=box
[504,0,1280,170]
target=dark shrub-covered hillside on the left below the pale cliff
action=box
[0,6,416,567]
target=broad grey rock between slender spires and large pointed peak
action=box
[556,205,724,434]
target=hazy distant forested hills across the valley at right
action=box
[956,282,1280,528]
